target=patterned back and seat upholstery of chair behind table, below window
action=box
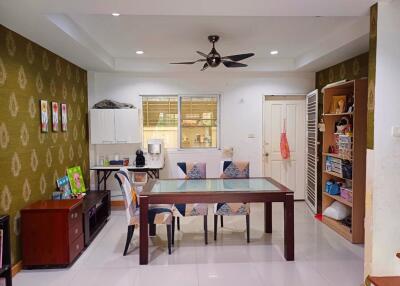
[174,162,208,216]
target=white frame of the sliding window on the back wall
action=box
[140,93,221,151]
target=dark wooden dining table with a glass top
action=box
[139,178,294,264]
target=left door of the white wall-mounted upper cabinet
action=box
[90,109,115,144]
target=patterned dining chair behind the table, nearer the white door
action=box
[214,161,250,243]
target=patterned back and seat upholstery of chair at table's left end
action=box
[115,168,172,225]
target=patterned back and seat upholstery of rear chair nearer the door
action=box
[214,161,250,216]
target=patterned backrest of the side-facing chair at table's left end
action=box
[114,168,139,224]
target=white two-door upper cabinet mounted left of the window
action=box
[90,109,140,144]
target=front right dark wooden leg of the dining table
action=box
[283,194,294,261]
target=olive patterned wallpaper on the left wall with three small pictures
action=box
[0,25,89,263]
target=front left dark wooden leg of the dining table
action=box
[139,196,149,265]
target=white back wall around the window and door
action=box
[88,71,315,198]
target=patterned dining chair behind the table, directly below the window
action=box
[172,162,208,244]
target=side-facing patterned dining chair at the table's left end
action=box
[115,168,173,256]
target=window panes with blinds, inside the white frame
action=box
[142,95,219,149]
